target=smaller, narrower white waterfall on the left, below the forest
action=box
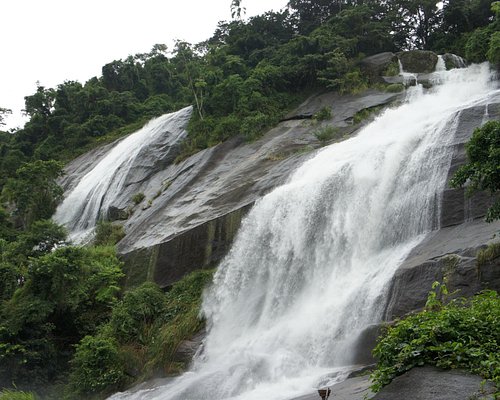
[54,107,191,243]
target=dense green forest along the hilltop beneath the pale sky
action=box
[0,0,500,185]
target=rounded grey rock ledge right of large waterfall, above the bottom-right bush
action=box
[385,220,500,321]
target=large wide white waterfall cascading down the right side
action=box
[112,65,496,400]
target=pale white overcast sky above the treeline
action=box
[0,0,288,128]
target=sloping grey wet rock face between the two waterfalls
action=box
[59,90,401,287]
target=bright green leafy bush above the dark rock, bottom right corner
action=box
[371,285,500,395]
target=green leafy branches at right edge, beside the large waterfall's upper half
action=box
[451,121,500,222]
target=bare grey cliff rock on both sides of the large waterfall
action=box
[59,52,500,304]
